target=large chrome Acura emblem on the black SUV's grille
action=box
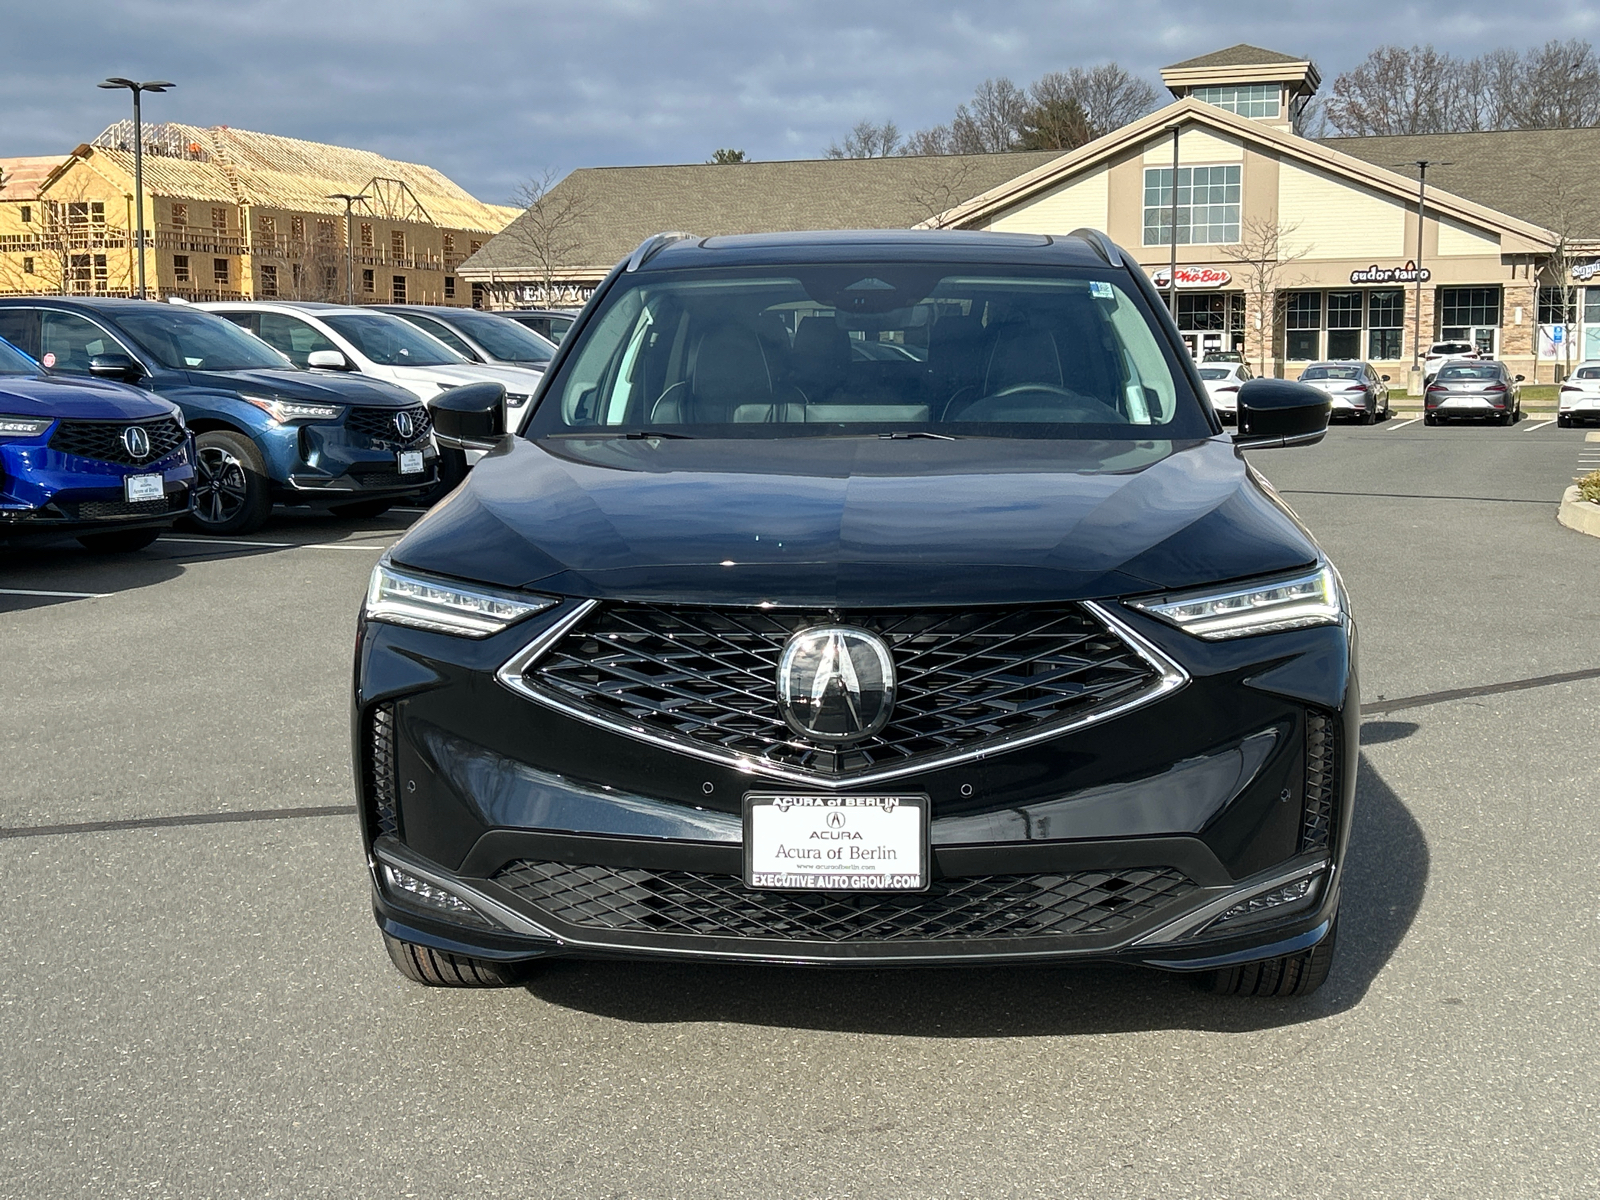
[778,626,894,742]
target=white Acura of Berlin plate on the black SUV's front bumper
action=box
[744,795,928,891]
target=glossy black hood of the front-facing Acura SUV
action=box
[392,437,1317,606]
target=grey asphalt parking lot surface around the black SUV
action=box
[0,418,1600,1198]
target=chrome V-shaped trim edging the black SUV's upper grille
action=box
[494,600,1189,789]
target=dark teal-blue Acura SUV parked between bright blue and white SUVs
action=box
[0,296,438,534]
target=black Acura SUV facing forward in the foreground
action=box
[354,230,1358,995]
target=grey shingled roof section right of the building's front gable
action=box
[1322,128,1600,240]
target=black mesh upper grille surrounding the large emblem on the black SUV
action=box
[523,605,1160,778]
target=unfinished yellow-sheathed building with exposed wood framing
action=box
[0,122,517,306]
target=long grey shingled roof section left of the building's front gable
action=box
[459,150,1059,278]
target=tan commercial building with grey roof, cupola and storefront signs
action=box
[462,45,1600,384]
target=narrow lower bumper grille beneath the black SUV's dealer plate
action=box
[494,859,1195,942]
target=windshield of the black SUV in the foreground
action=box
[528,264,1213,438]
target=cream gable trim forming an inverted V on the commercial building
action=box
[926,98,1555,246]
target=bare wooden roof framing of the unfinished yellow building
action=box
[78,123,515,234]
